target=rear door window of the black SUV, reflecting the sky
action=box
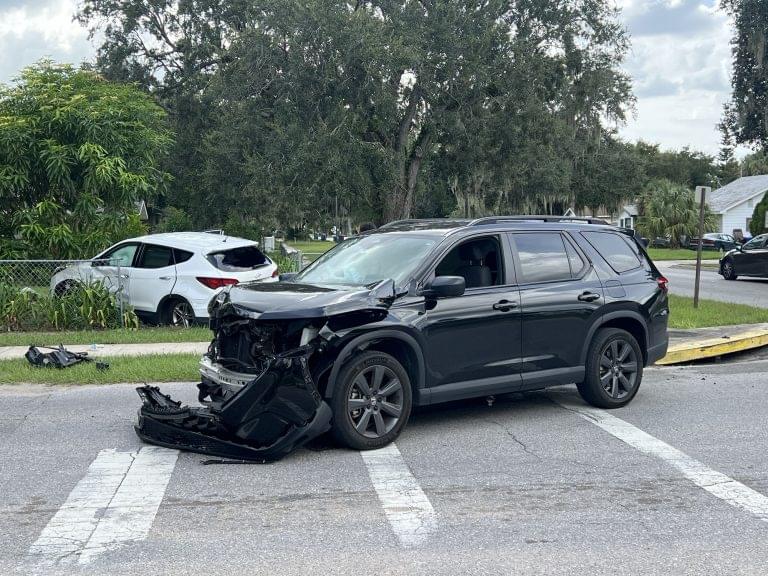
[513,232,572,283]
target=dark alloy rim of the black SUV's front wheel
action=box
[347,365,403,438]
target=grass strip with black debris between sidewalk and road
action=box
[0,354,200,384]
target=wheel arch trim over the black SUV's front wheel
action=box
[323,330,426,403]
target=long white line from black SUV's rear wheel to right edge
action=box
[551,394,768,522]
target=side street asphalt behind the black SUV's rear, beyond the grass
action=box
[656,262,768,308]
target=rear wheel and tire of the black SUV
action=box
[578,328,643,408]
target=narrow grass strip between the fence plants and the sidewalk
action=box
[0,326,212,346]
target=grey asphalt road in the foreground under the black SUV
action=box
[0,361,768,576]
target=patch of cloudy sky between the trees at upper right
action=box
[621,0,744,154]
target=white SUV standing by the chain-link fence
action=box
[51,232,277,326]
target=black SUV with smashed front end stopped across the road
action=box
[137,216,669,458]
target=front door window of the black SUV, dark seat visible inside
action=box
[435,236,504,288]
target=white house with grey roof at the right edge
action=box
[706,175,768,234]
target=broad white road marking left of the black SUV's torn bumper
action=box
[29,446,178,566]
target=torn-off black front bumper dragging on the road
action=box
[135,346,331,461]
